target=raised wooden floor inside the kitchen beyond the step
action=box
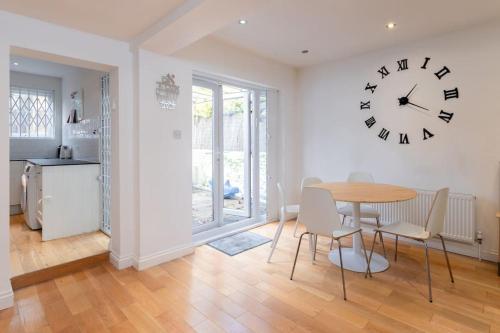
[10,215,109,277]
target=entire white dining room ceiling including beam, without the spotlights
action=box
[0,0,500,67]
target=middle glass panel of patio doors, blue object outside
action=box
[222,85,251,224]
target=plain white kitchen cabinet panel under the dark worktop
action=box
[36,164,100,241]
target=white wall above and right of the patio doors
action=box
[175,37,300,219]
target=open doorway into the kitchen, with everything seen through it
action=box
[9,53,111,280]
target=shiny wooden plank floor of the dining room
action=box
[0,220,500,333]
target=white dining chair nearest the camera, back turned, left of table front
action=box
[290,187,371,300]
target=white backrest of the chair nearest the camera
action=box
[300,187,341,237]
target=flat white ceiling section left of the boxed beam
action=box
[0,0,184,40]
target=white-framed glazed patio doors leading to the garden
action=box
[192,78,267,233]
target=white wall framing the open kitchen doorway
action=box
[0,11,138,308]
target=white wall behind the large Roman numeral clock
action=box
[298,23,500,258]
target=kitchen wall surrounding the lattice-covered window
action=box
[7,71,62,159]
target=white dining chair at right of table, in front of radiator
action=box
[368,188,455,302]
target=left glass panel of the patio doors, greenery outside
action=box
[192,84,218,232]
